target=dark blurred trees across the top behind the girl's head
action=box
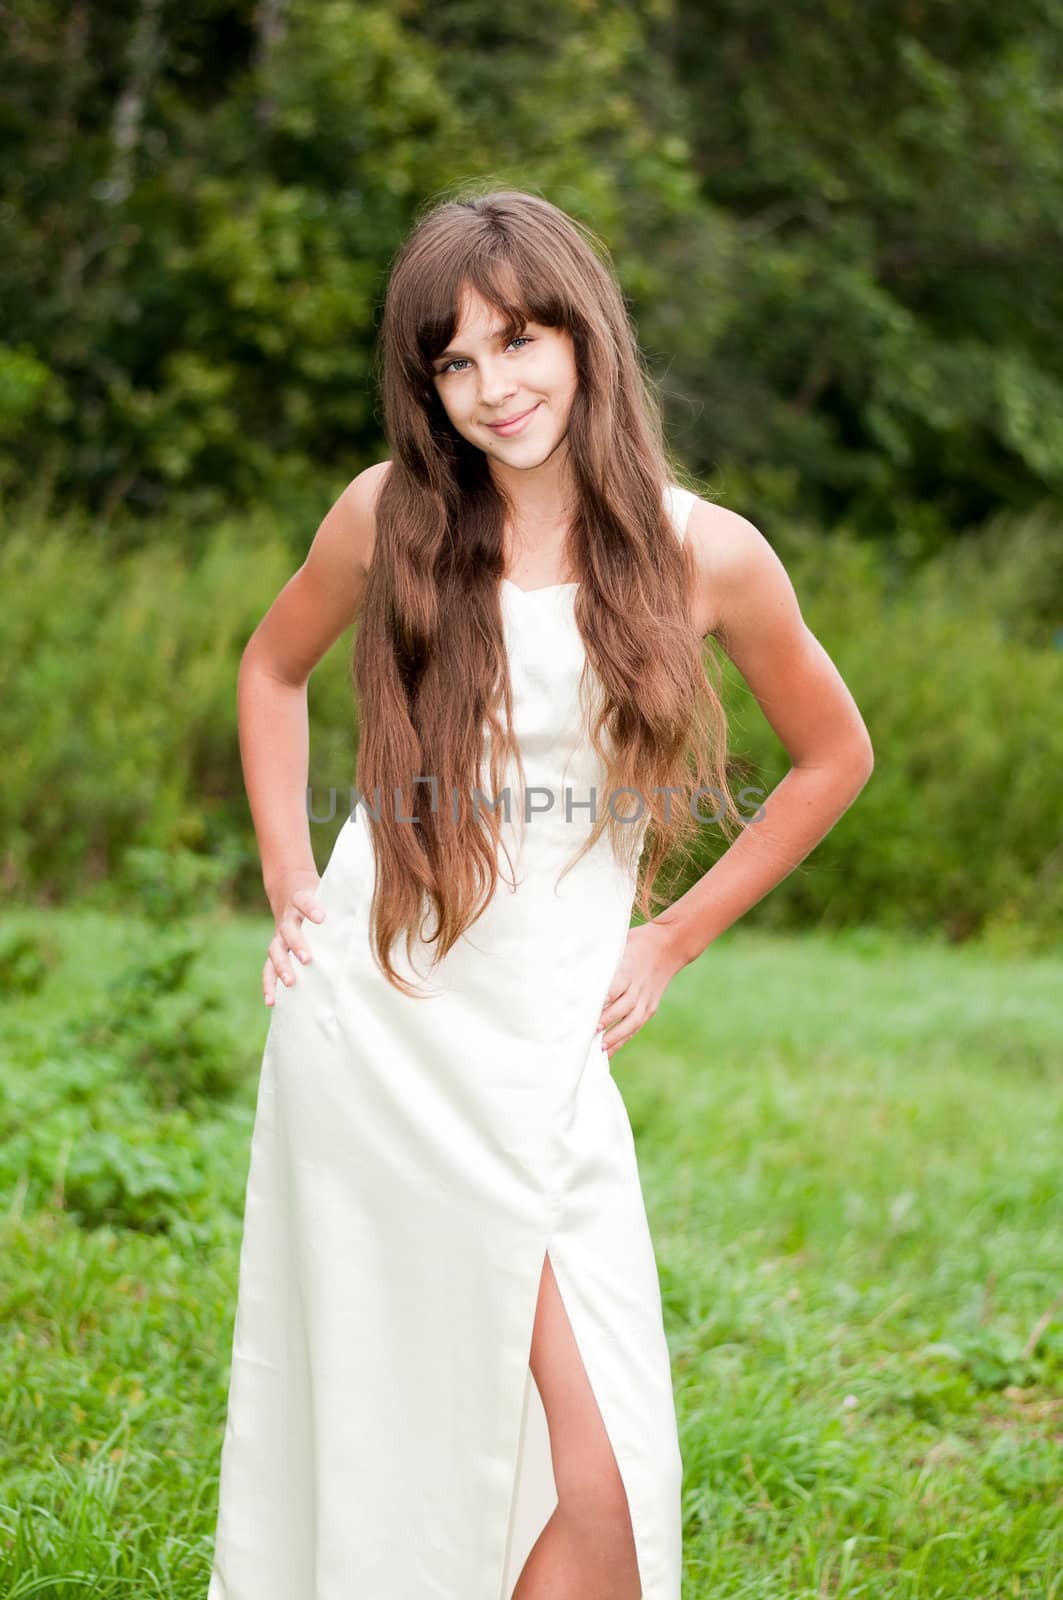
[0,0,1063,550]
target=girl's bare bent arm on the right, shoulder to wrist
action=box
[653,501,874,970]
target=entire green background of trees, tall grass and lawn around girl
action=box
[0,0,1063,1600]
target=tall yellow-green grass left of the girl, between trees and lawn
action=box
[0,515,354,906]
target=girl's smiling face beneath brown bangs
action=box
[432,291,578,470]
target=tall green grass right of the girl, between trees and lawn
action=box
[669,515,1063,947]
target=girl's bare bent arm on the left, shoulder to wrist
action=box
[237,461,389,928]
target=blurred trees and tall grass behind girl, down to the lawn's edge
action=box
[0,0,1063,941]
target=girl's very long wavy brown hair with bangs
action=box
[354,189,738,994]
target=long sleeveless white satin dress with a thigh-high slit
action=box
[208,486,695,1600]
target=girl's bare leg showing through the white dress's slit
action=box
[512,1253,642,1600]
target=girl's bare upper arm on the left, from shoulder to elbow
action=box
[240,461,391,685]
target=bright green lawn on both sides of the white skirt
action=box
[0,910,1063,1600]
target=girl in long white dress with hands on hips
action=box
[208,190,872,1600]
